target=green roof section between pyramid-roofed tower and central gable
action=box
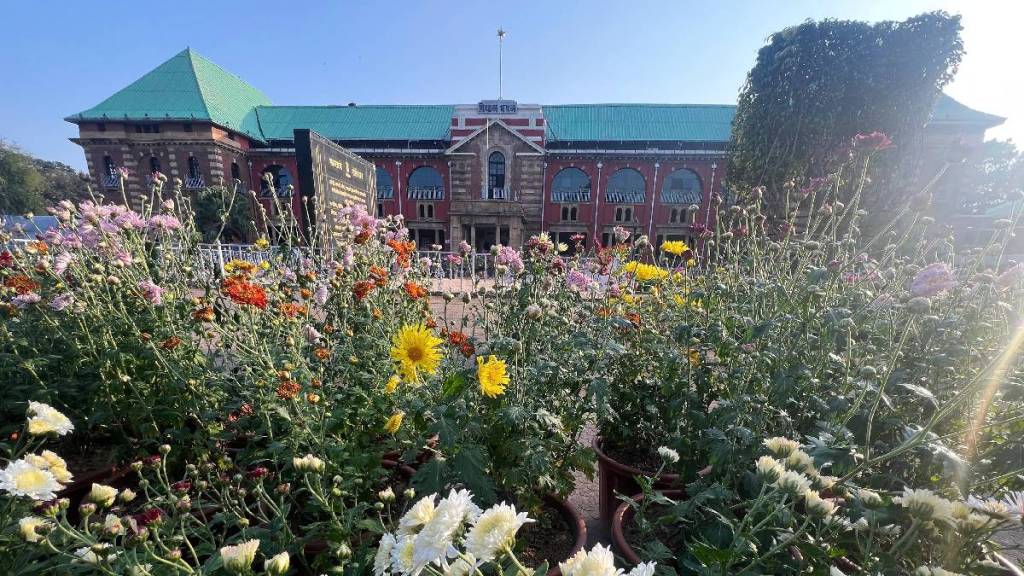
[256,106,455,140]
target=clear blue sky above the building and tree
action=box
[0,0,1024,168]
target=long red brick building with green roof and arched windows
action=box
[68,49,997,250]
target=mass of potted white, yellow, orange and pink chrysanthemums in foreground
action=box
[0,137,1024,576]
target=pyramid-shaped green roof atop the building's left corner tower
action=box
[68,48,270,139]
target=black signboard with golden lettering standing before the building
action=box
[295,128,377,245]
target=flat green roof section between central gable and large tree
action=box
[544,104,736,141]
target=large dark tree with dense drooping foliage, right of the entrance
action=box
[729,12,963,222]
